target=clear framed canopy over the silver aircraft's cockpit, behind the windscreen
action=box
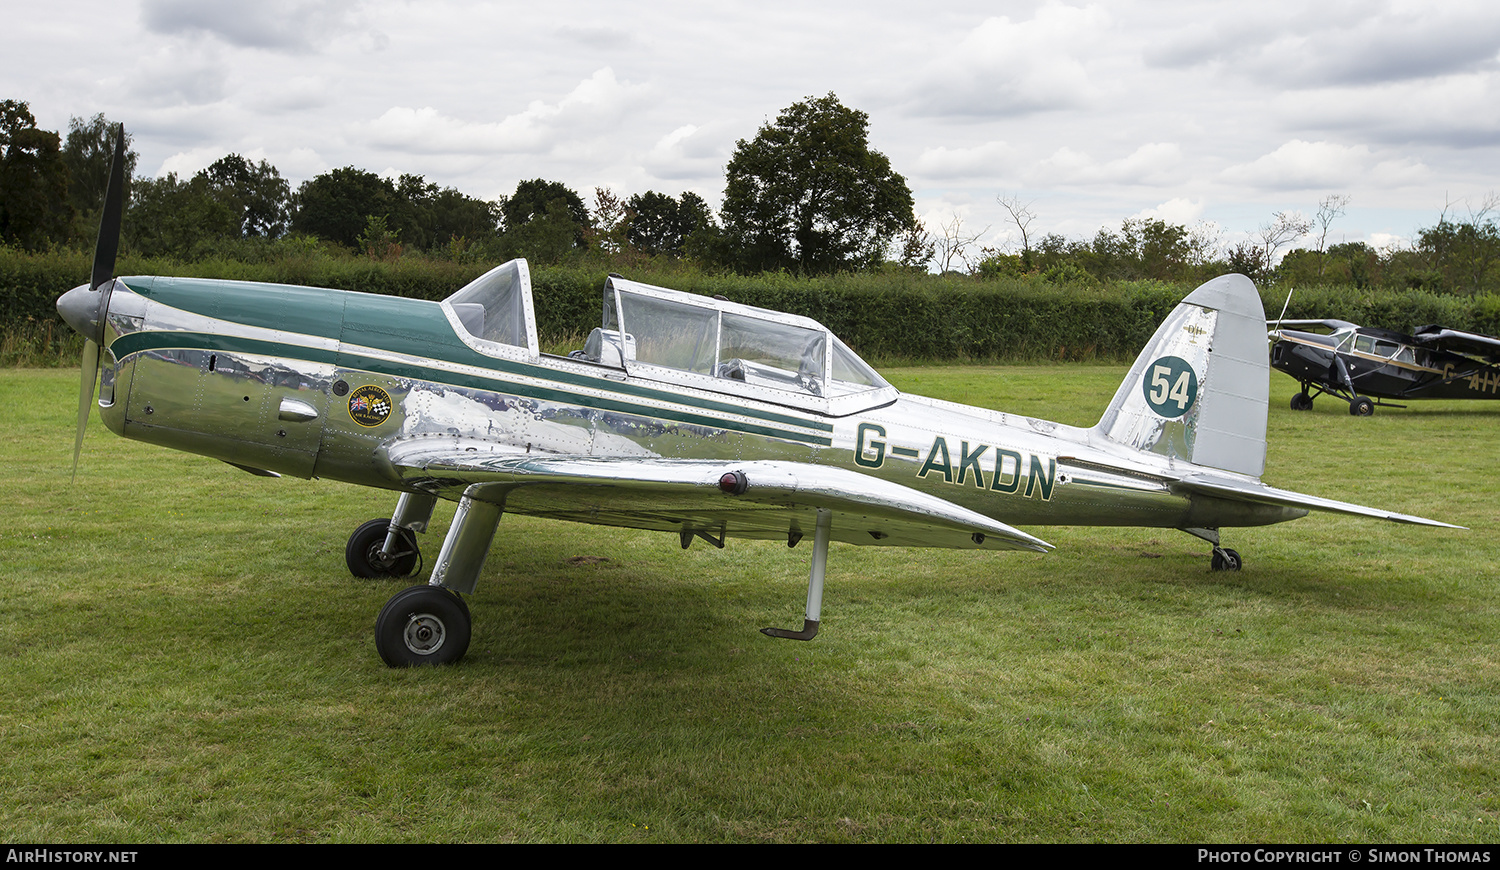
[579,276,897,416]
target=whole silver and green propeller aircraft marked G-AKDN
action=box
[57,132,1458,666]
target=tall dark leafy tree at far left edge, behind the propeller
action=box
[0,99,74,251]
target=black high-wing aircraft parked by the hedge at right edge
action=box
[1271,320,1500,417]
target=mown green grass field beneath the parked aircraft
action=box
[0,366,1500,842]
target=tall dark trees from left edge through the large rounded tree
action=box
[0,95,918,275]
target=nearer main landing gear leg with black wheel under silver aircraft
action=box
[375,494,501,668]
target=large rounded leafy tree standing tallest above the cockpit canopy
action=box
[722,93,917,275]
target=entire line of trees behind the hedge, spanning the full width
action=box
[0,93,1500,294]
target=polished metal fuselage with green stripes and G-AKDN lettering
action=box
[99,278,1304,543]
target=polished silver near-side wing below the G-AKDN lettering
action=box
[390,440,1052,552]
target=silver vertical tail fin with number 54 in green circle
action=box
[1094,275,1271,477]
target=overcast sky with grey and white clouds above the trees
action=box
[0,0,1500,258]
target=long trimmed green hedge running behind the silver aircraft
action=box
[0,248,1500,362]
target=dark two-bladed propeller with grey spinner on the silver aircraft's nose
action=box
[57,125,125,477]
